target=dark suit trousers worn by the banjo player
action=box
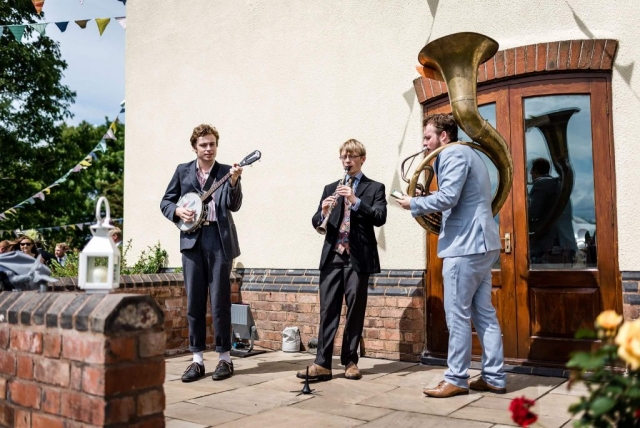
[182,222,231,352]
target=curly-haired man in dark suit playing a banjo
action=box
[160,124,242,382]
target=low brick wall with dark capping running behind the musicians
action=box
[51,269,425,361]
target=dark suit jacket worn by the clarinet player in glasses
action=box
[311,175,387,273]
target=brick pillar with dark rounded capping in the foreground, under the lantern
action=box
[0,292,165,428]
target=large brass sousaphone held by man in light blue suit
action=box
[407,33,513,234]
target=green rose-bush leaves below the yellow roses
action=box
[567,328,640,427]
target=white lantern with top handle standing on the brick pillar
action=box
[78,196,120,293]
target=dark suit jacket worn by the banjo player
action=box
[160,160,242,261]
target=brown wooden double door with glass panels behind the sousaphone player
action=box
[425,76,622,365]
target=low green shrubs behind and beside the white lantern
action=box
[51,240,169,278]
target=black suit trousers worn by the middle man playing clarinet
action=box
[315,251,369,369]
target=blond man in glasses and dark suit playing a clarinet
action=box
[297,140,387,380]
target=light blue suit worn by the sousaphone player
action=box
[411,144,506,388]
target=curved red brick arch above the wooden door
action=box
[413,39,618,104]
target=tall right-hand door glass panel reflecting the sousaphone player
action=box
[524,95,597,269]
